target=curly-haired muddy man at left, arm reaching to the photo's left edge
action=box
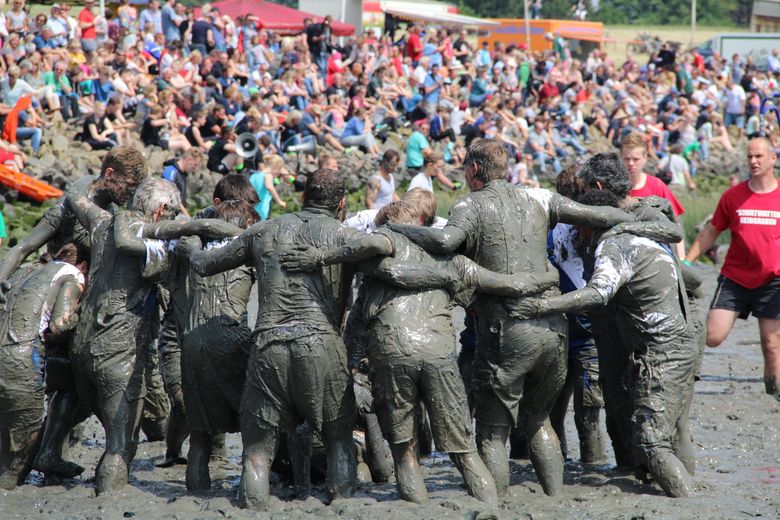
[0,146,147,478]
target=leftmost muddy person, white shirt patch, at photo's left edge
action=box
[0,243,88,489]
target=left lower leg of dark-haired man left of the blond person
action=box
[238,426,276,511]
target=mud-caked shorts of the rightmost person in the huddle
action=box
[631,330,699,457]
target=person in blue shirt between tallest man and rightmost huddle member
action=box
[550,164,604,464]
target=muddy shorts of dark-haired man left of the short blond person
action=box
[241,327,355,431]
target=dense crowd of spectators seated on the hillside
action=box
[0,0,780,199]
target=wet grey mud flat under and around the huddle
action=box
[0,268,780,520]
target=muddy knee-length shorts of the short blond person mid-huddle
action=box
[369,356,476,453]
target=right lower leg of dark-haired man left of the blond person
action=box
[322,419,357,498]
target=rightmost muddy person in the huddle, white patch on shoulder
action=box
[516,190,699,497]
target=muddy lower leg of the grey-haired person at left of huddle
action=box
[95,392,143,495]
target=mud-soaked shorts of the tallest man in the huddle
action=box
[472,309,568,427]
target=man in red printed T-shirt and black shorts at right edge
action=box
[686,137,780,401]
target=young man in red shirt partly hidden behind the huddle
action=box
[620,132,685,258]
